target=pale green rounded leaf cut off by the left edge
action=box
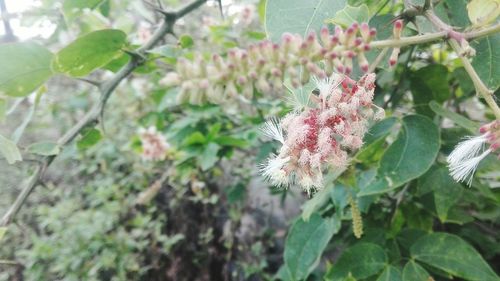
[0,42,52,97]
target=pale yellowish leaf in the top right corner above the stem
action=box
[467,0,500,26]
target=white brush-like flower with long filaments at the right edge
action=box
[447,120,500,186]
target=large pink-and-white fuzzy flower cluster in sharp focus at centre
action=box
[262,73,384,193]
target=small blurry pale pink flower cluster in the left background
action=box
[139,126,170,161]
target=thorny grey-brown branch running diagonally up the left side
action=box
[0,0,207,227]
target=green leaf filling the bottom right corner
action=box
[410,233,499,281]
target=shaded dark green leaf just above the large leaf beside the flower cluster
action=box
[410,64,450,117]
